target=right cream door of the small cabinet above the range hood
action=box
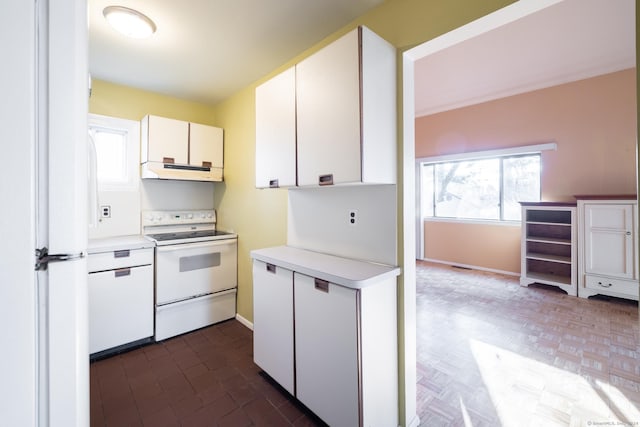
[189,123,224,169]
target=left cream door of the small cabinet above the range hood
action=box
[141,116,189,164]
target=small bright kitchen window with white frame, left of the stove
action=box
[89,114,140,191]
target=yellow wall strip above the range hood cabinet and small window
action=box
[89,79,216,125]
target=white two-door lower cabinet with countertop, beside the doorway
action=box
[252,247,399,427]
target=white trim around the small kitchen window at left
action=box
[88,114,140,191]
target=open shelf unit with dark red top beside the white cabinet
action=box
[520,202,578,296]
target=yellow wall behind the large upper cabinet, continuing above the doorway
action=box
[215,0,512,320]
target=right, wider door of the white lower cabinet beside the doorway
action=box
[295,273,362,427]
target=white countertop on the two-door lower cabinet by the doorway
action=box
[251,246,400,289]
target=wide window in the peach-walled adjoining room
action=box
[419,144,555,221]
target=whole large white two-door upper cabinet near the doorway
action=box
[256,27,397,188]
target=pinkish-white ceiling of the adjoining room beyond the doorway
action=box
[415,0,636,116]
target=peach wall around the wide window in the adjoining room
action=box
[416,68,637,273]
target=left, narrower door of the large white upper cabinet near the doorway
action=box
[256,67,296,188]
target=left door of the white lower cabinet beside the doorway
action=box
[253,260,295,395]
